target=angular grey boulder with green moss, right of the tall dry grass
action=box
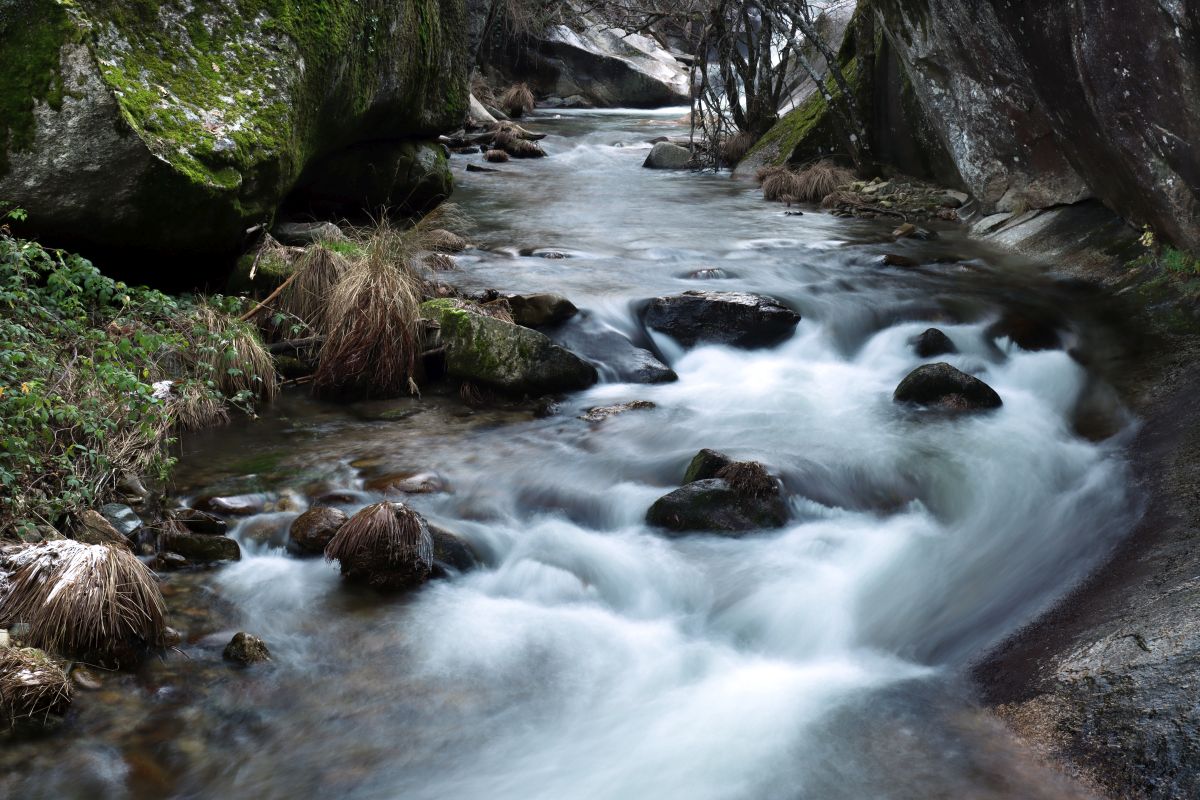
[421,299,598,395]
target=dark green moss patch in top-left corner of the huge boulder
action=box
[0,0,78,175]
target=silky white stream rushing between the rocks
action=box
[0,109,1138,800]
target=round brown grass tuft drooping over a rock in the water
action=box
[325,503,433,589]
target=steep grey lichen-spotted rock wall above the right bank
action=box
[876,0,1200,248]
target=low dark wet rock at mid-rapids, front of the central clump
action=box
[646,479,788,534]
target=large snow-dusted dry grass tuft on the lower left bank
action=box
[0,540,167,663]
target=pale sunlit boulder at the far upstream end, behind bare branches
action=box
[486,18,689,108]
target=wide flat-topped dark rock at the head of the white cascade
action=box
[642,291,800,348]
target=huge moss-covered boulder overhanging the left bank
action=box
[0,0,470,267]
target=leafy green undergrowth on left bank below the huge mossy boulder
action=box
[0,227,275,533]
